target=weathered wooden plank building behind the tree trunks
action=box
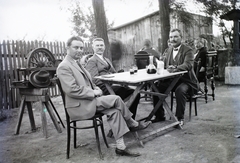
[108,11,212,69]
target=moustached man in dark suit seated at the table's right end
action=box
[152,29,199,125]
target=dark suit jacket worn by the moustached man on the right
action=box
[164,44,199,91]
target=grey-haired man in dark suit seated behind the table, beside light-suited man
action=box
[86,38,140,119]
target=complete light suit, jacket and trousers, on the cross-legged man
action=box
[57,55,132,140]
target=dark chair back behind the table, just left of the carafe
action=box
[134,51,149,69]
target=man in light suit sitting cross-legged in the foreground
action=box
[57,37,149,157]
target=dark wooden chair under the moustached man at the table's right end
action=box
[171,59,202,121]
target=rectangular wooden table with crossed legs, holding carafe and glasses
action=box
[95,69,187,143]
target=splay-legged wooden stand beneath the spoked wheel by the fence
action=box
[15,88,65,138]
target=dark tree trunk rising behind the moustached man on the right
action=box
[158,0,170,53]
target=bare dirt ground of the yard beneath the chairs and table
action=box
[0,82,240,163]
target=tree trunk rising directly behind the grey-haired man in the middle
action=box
[92,0,112,60]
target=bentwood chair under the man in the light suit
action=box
[56,78,109,159]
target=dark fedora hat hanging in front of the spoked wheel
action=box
[29,70,51,88]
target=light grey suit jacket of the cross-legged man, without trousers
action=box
[57,55,97,120]
